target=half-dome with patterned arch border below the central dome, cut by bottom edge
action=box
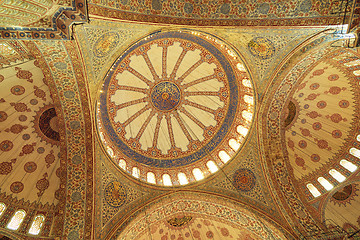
[117,192,286,240]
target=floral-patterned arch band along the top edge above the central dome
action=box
[89,0,352,26]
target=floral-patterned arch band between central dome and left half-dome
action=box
[28,41,94,239]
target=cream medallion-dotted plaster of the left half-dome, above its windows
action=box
[0,43,60,207]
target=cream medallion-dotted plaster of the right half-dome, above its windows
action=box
[284,57,358,180]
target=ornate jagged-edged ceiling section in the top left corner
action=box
[0,0,87,39]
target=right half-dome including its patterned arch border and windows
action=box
[262,33,360,237]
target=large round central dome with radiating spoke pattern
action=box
[97,31,253,187]
